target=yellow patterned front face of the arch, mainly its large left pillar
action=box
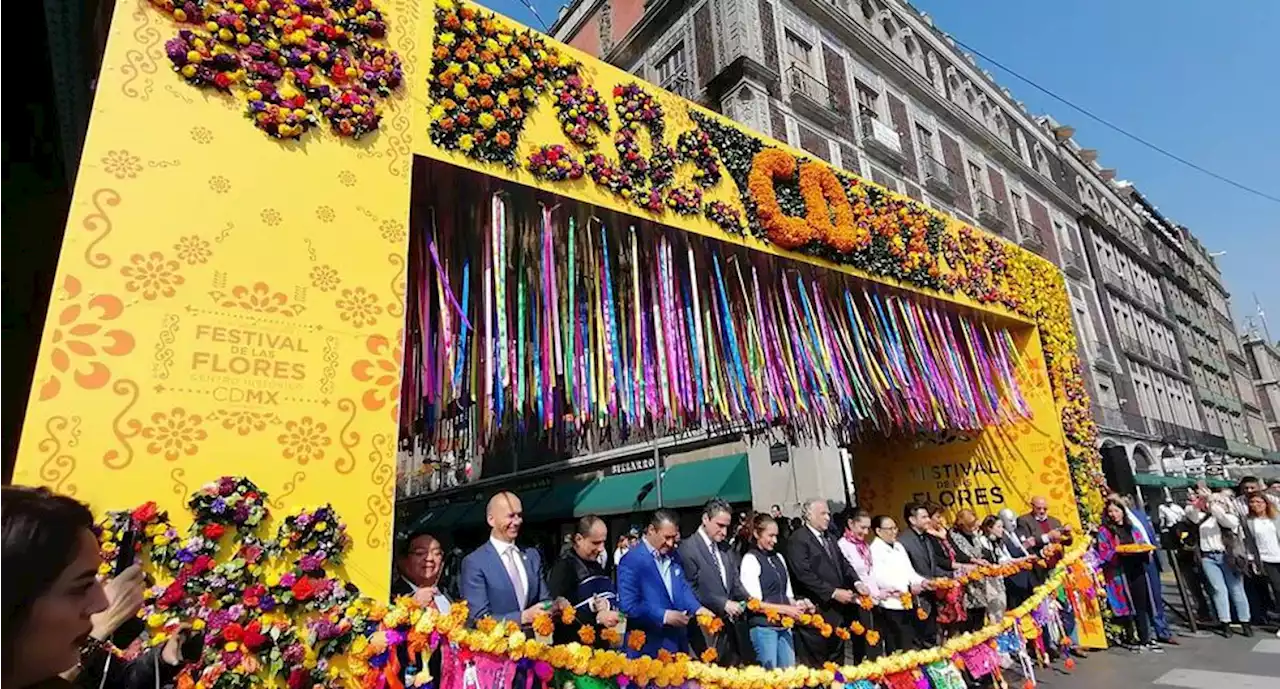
[15,0,1070,596]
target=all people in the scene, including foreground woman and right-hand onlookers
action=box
[10,479,1280,689]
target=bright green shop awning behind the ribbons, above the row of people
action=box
[573,453,751,516]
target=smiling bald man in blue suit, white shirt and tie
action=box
[461,492,550,625]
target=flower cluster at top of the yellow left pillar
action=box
[151,0,403,140]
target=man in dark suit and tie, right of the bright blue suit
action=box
[680,498,746,666]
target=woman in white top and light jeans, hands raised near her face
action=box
[1187,489,1253,636]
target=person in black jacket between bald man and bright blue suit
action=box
[548,515,622,648]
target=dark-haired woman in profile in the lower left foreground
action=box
[0,487,180,689]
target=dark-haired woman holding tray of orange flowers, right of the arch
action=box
[1097,499,1164,653]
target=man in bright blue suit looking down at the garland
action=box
[618,510,710,657]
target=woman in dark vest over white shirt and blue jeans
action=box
[739,514,813,670]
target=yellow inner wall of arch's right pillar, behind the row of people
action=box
[852,328,1080,528]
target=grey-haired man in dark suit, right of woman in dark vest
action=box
[787,499,870,667]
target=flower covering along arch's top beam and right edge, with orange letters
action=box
[431,0,1102,524]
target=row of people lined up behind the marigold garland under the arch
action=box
[393,493,1074,667]
